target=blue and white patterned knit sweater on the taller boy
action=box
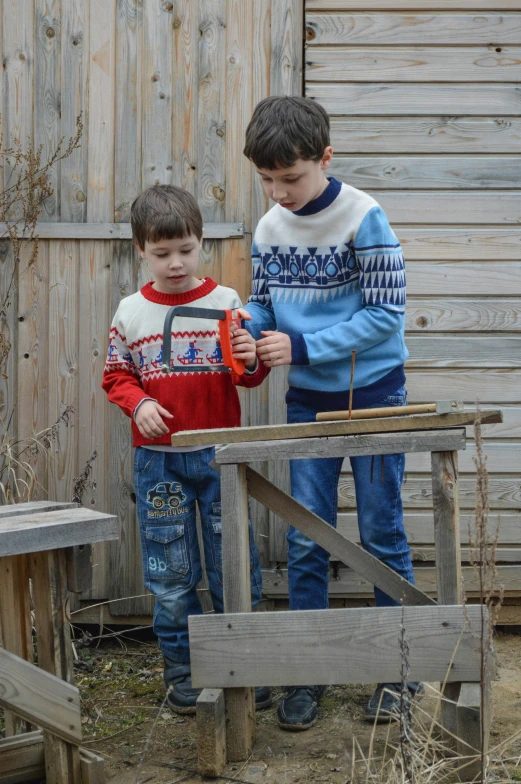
[246,178,408,407]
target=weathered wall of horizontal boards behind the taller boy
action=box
[296,0,521,590]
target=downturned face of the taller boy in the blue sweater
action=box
[257,147,333,212]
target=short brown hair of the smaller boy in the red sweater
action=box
[130,185,203,250]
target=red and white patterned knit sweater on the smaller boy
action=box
[102,278,269,446]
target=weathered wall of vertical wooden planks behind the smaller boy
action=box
[0,0,304,615]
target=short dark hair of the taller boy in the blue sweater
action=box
[244,95,329,169]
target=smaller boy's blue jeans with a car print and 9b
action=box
[134,447,262,663]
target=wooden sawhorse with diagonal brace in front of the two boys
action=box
[172,411,502,778]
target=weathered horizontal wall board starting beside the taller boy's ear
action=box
[330,158,521,190]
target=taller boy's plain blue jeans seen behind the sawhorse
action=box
[287,387,414,610]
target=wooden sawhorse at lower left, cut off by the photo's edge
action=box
[0,501,119,784]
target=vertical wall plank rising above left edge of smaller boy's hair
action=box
[114,0,142,222]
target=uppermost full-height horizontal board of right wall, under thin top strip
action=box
[306,9,521,50]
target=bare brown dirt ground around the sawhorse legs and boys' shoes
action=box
[64,630,521,784]
